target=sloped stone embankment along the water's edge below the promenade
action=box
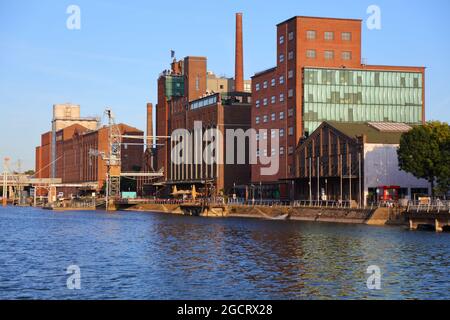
[127,204,404,226]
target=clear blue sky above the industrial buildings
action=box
[0,0,450,169]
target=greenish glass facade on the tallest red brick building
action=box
[303,68,423,134]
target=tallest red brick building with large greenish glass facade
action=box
[252,16,425,199]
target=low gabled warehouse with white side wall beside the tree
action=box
[291,121,431,206]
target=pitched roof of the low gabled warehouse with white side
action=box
[326,121,411,144]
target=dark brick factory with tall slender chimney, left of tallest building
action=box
[155,14,251,194]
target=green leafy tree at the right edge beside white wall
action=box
[398,122,450,196]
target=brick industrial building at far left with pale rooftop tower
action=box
[35,104,143,197]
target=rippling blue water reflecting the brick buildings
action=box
[0,208,450,299]
